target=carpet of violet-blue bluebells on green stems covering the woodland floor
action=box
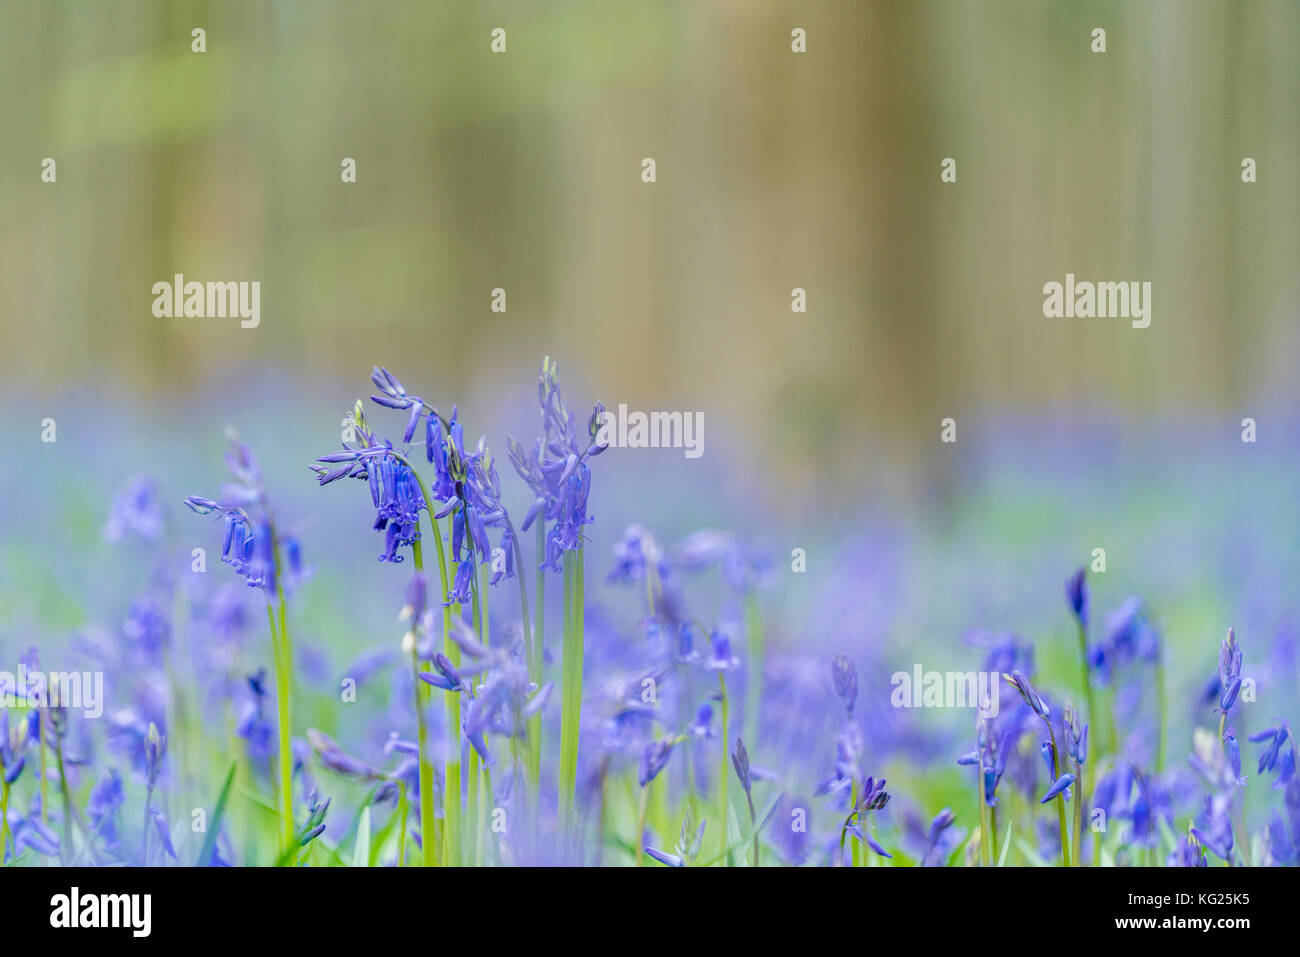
[0,360,1300,867]
